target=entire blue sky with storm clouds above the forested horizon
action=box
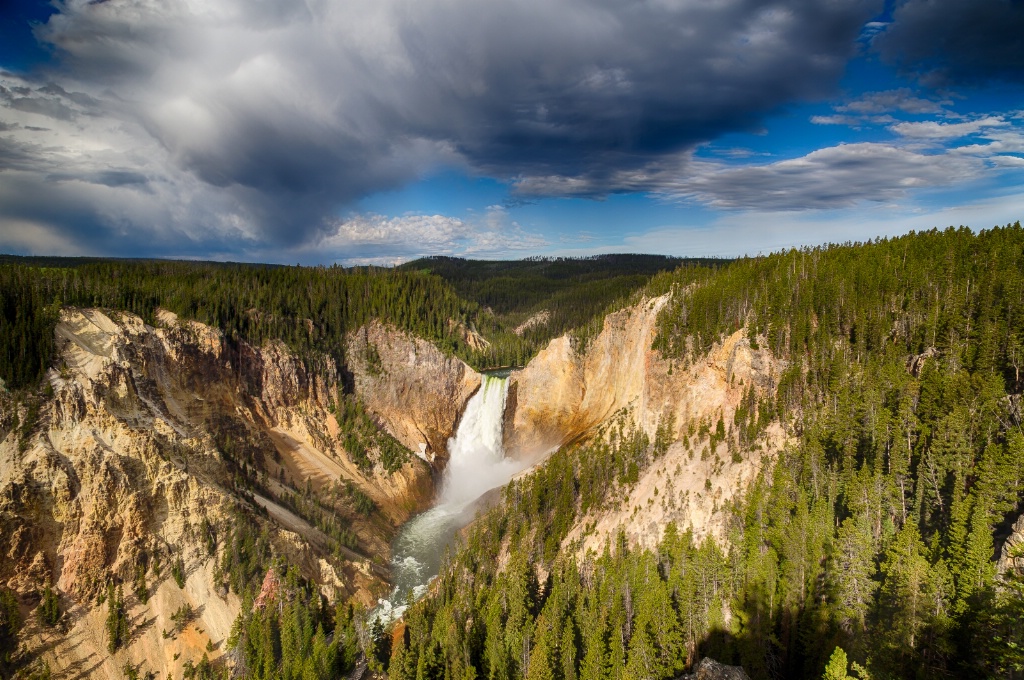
[0,0,1024,265]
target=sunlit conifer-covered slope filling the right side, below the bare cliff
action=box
[389,223,1024,680]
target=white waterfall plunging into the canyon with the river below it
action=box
[375,375,523,621]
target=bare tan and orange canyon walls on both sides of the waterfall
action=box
[0,294,1007,678]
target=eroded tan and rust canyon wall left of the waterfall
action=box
[0,309,478,678]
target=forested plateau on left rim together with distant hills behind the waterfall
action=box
[0,255,696,389]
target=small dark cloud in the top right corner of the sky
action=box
[874,0,1024,86]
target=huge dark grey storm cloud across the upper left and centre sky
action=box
[5,0,881,247]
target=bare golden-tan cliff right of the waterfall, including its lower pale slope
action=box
[506,295,785,550]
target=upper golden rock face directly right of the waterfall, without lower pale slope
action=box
[505,295,777,456]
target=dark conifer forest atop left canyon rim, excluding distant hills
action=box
[0,258,503,388]
